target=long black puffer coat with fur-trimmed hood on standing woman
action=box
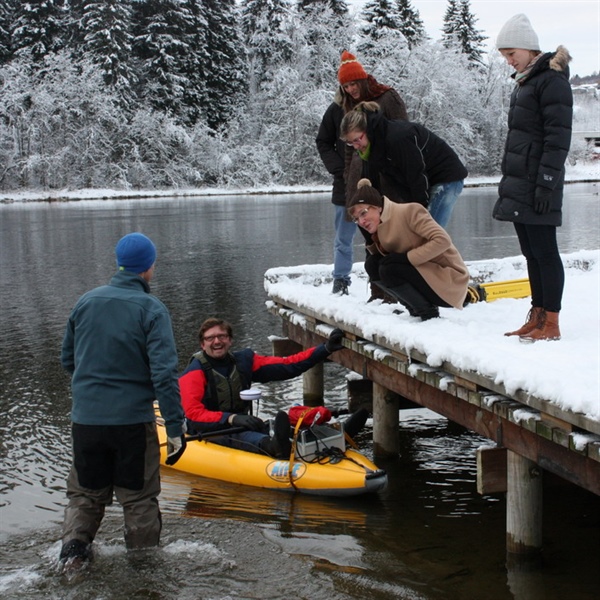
[493,46,573,226]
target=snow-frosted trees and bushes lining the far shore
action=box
[0,0,598,189]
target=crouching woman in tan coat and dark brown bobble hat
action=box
[348,179,469,321]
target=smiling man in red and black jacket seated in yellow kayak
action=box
[179,318,343,458]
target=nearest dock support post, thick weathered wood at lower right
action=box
[506,450,543,562]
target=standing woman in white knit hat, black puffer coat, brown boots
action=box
[493,14,573,342]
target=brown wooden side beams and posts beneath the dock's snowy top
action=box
[268,264,600,556]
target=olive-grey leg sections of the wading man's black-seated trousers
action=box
[62,423,162,549]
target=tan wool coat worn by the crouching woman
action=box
[368,196,469,309]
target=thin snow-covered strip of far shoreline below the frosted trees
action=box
[0,170,600,205]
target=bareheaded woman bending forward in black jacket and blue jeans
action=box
[340,102,467,227]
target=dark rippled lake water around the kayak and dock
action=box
[0,184,600,600]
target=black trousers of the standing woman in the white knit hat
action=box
[514,223,565,312]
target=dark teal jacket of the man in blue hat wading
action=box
[61,271,184,437]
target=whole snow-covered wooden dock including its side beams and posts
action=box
[264,250,600,553]
